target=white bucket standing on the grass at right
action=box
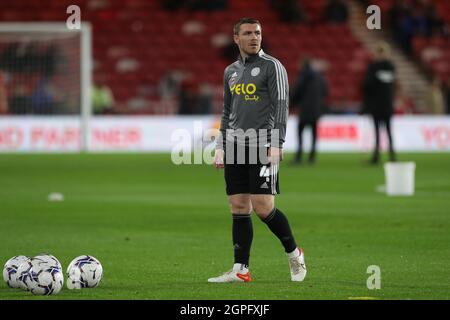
[384,162,416,196]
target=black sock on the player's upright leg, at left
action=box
[233,213,253,266]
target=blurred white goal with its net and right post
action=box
[0,23,92,149]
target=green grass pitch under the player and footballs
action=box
[0,153,450,300]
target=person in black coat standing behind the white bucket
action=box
[363,42,396,164]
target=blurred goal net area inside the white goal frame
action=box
[0,25,86,114]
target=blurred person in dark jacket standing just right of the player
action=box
[291,59,328,164]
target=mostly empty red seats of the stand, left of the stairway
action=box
[0,0,369,114]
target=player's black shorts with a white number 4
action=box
[224,147,280,195]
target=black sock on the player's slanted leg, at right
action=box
[262,208,297,253]
